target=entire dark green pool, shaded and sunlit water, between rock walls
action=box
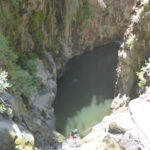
[54,43,119,136]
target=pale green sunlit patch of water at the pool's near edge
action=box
[63,95,111,137]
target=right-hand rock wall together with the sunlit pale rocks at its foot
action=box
[63,0,150,150]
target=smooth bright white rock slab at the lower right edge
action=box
[129,98,150,149]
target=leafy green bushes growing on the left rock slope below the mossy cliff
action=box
[0,33,39,101]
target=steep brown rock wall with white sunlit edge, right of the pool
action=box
[112,0,150,108]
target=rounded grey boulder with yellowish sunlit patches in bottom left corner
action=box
[0,119,34,150]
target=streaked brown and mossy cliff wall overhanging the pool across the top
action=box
[1,0,135,73]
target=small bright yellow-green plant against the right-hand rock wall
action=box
[136,66,146,90]
